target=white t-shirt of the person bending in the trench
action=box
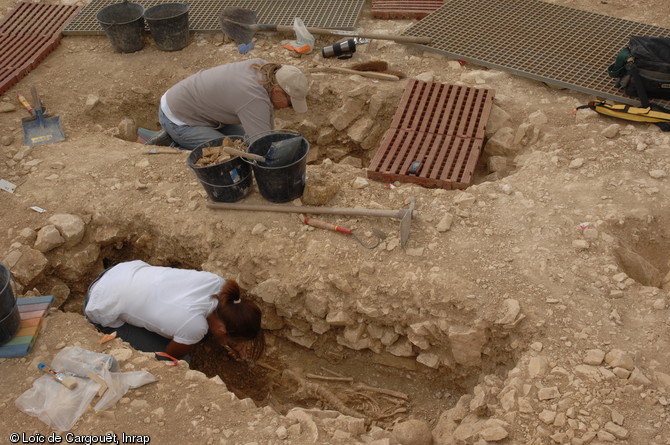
[85,260,226,345]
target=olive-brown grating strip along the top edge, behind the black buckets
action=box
[63,0,365,35]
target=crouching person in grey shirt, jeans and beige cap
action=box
[147,59,309,150]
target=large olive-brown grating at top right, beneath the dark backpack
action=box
[406,0,670,106]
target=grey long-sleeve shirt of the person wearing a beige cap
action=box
[165,59,274,138]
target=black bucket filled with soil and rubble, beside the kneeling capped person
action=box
[186,136,254,202]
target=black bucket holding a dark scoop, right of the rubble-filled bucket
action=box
[245,130,309,202]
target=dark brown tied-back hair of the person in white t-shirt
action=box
[216,280,261,340]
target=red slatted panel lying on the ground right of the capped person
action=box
[367,79,495,189]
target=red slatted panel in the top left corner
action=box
[0,2,81,94]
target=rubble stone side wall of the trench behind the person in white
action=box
[6,214,530,426]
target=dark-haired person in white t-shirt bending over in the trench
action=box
[84,260,261,360]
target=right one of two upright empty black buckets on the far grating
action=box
[144,3,189,51]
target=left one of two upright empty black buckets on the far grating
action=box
[95,2,144,53]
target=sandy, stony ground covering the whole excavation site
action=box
[0,0,670,445]
